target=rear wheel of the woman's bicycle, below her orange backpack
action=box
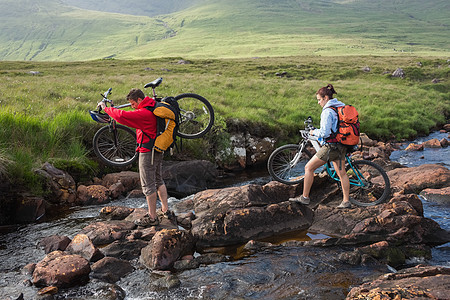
[347,160,391,206]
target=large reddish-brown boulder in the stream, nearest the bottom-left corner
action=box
[33,251,91,288]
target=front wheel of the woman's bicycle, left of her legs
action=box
[267,144,312,184]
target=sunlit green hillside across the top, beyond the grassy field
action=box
[0,0,450,61]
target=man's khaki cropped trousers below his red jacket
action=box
[139,151,164,196]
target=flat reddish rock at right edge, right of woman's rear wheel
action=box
[387,164,450,193]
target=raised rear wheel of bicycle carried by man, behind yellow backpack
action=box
[175,93,214,139]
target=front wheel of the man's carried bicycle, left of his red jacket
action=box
[93,124,138,167]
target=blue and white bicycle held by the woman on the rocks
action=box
[267,117,390,206]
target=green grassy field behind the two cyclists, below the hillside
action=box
[0,56,450,192]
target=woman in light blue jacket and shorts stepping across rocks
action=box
[289,84,351,208]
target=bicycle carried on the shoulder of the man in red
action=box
[89,77,214,167]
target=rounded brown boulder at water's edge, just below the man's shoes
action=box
[140,229,194,270]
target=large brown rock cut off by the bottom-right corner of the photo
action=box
[346,265,450,300]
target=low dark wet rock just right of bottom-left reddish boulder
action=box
[91,257,134,283]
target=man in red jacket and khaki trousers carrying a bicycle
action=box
[98,89,171,226]
